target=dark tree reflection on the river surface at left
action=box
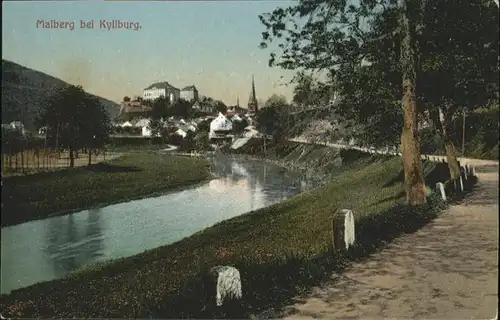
[45,209,104,277]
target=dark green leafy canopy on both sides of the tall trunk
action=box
[259,0,498,145]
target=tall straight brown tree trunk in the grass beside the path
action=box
[401,0,427,205]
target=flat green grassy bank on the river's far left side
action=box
[2,153,210,226]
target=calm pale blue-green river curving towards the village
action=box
[1,156,316,293]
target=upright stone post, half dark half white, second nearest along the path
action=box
[332,209,356,251]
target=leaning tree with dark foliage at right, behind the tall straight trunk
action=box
[419,0,499,179]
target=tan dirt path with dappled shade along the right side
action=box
[265,159,498,319]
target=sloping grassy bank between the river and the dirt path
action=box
[1,154,462,318]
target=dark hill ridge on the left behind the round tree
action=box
[1,59,120,129]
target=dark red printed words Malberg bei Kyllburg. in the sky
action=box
[36,19,142,31]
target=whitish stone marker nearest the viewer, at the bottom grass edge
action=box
[210,266,242,307]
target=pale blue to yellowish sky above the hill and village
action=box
[2,0,294,106]
